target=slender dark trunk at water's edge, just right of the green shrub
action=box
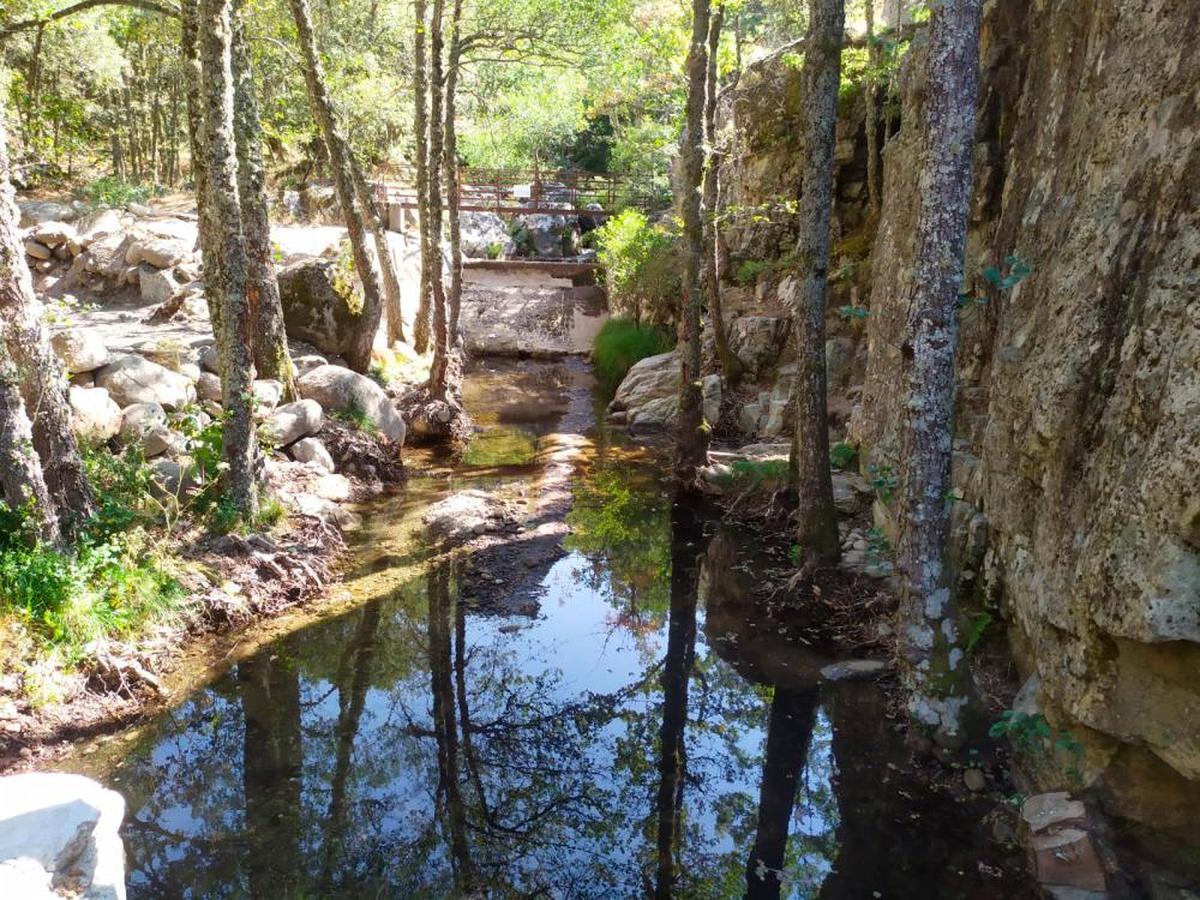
[676,0,709,481]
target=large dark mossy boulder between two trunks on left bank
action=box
[280,259,362,355]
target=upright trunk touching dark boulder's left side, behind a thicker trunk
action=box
[233,0,296,402]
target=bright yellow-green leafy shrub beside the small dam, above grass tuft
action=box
[596,209,683,324]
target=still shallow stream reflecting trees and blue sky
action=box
[82,361,1036,899]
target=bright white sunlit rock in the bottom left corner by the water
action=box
[0,773,125,900]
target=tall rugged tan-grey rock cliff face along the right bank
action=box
[726,0,1200,846]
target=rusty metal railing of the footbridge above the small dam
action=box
[374,166,664,217]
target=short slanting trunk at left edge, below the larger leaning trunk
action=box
[0,341,62,545]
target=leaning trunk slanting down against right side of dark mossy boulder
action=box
[290,0,383,372]
